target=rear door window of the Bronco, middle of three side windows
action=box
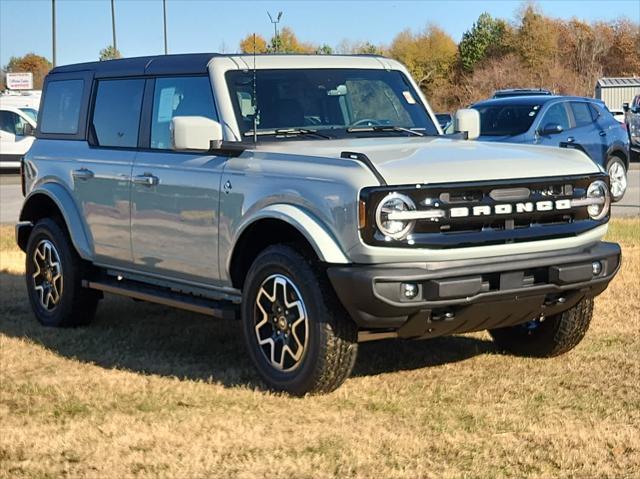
[91,79,144,148]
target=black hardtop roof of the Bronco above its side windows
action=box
[49,53,220,77]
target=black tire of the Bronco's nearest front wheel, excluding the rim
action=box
[242,245,357,396]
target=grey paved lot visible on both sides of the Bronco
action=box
[0,163,640,223]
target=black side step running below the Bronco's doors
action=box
[82,278,239,319]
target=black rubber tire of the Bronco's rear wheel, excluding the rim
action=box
[25,218,101,327]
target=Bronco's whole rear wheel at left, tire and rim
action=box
[25,218,100,327]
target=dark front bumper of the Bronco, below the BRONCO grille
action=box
[327,242,621,337]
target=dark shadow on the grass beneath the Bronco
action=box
[0,271,497,388]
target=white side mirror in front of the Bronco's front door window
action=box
[171,116,222,150]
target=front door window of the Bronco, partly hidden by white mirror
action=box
[151,76,218,150]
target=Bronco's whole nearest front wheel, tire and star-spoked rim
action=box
[242,245,357,395]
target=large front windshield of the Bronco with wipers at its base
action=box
[226,69,438,137]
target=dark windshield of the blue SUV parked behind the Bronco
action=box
[473,104,540,136]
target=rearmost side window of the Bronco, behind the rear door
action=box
[40,80,84,135]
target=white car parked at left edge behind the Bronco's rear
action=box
[0,103,38,169]
